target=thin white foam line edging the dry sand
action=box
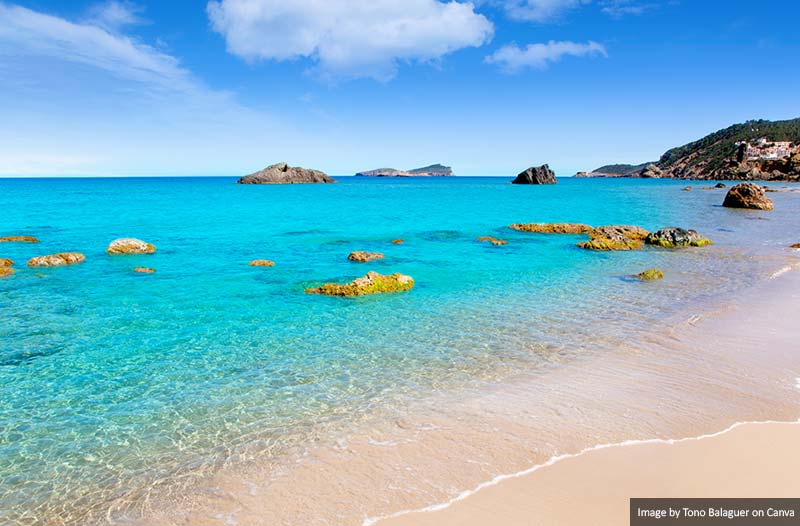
[361,420,800,526]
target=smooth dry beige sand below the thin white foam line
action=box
[377,423,800,526]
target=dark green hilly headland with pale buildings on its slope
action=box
[576,119,800,181]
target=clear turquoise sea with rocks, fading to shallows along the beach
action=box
[0,178,800,524]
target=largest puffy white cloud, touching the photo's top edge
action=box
[207,0,494,80]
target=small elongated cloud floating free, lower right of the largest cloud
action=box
[486,40,608,73]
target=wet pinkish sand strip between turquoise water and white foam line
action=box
[130,256,800,525]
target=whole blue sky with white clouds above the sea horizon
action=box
[0,0,800,177]
